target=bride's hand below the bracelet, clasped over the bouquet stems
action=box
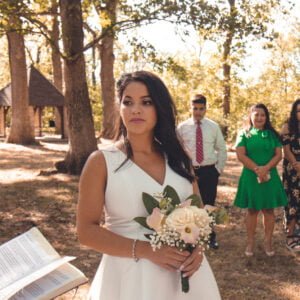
[148,246,190,271]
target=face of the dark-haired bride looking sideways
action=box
[120,82,157,134]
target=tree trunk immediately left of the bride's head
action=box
[100,0,118,139]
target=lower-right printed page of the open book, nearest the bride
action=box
[11,263,88,300]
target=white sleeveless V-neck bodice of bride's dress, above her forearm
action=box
[102,145,193,240]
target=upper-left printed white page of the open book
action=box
[0,227,60,291]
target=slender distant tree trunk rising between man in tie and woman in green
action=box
[223,0,235,118]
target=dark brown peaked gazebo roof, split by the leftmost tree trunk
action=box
[0,66,65,106]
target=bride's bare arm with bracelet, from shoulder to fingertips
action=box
[77,151,188,269]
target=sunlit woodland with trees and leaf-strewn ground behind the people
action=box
[0,0,300,300]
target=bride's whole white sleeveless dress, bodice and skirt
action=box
[89,145,221,300]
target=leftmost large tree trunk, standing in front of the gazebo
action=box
[7,15,35,145]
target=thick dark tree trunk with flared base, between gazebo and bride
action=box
[56,0,97,174]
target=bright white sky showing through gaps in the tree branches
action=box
[120,0,300,79]
